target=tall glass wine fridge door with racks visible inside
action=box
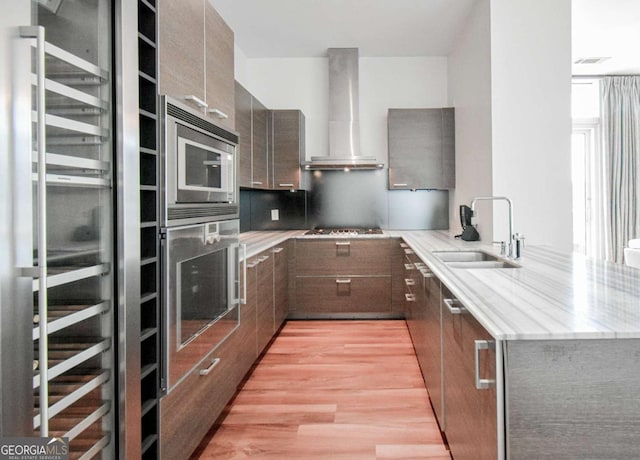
[28,0,117,458]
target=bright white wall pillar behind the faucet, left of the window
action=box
[491,0,572,251]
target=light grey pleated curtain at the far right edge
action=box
[601,76,640,263]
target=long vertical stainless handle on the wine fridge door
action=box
[20,26,49,436]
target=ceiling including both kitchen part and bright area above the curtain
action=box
[209,0,640,75]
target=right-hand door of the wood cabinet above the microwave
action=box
[205,1,235,129]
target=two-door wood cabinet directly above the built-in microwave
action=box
[158,0,235,129]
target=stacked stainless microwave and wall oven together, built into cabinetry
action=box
[160,96,240,393]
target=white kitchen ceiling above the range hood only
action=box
[210,0,475,58]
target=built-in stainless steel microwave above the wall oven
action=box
[160,96,239,226]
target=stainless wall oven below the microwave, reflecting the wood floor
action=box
[161,219,240,391]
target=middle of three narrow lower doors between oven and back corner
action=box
[256,251,275,354]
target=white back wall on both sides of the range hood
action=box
[243,57,447,164]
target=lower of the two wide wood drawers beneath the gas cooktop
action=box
[296,276,391,313]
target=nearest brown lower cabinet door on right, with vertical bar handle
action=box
[442,286,498,460]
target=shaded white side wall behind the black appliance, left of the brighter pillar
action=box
[449,0,493,235]
